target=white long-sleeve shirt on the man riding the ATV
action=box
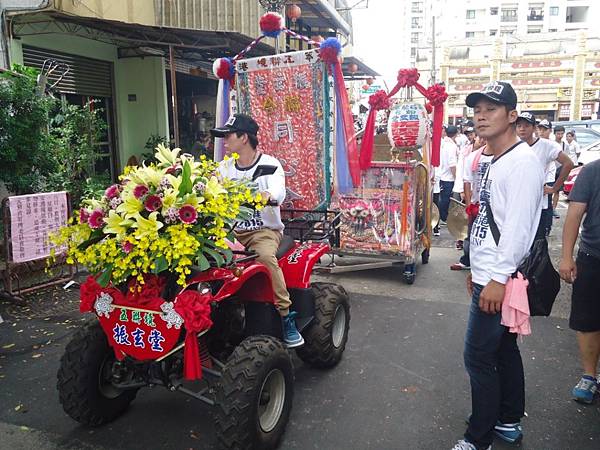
[219,154,286,231]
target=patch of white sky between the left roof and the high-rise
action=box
[348,0,409,89]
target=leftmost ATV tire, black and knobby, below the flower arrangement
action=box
[57,321,137,426]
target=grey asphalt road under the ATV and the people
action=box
[0,211,600,450]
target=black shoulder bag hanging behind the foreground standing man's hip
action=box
[485,195,560,316]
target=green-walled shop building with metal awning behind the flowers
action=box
[0,0,351,177]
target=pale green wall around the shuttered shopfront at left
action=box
[10,29,169,169]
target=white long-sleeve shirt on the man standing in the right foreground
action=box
[470,142,544,286]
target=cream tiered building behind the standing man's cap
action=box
[428,31,600,122]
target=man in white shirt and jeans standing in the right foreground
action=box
[453,81,544,450]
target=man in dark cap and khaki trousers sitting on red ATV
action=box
[210,114,304,348]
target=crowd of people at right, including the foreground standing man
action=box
[434,81,600,450]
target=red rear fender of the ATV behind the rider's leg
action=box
[279,242,330,289]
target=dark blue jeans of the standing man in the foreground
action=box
[464,284,525,448]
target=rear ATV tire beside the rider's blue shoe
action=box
[296,283,350,369]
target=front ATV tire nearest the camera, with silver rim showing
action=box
[215,335,294,450]
